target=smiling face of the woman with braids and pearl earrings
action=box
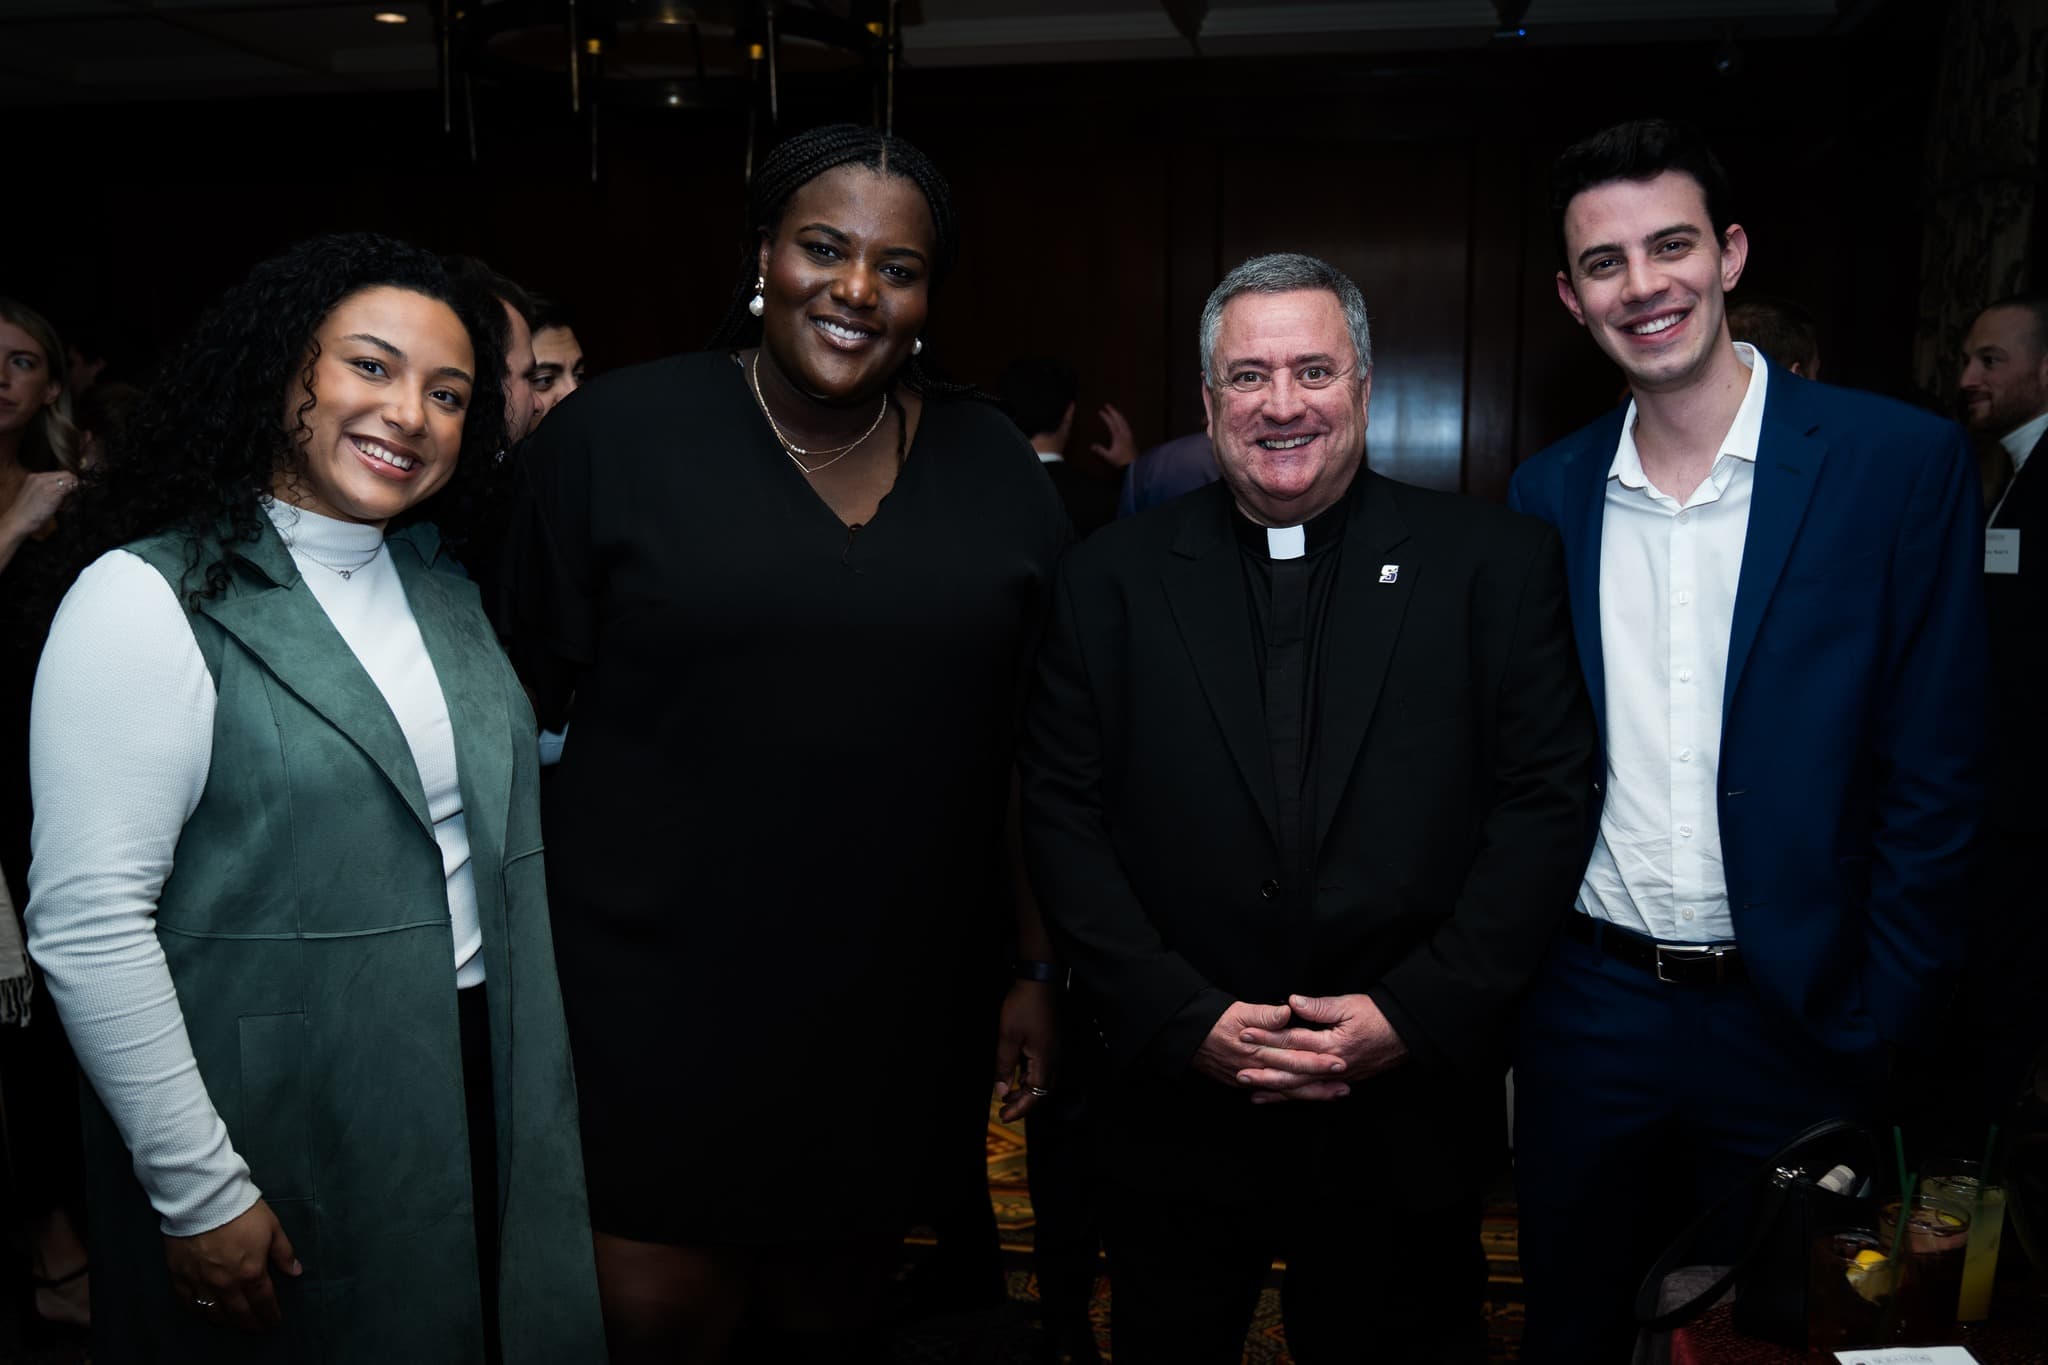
[760,166,936,403]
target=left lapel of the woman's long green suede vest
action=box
[199,522,434,837]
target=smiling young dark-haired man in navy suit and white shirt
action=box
[1509,121,1985,1365]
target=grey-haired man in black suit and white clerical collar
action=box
[1020,256,1593,1365]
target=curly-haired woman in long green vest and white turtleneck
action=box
[29,233,602,1365]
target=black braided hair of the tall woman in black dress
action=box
[709,123,987,397]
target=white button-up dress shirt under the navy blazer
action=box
[1579,342,1769,943]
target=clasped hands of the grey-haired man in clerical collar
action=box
[1194,995,1407,1105]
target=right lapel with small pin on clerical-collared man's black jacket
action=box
[1315,471,1430,847]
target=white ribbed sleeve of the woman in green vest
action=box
[27,551,260,1236]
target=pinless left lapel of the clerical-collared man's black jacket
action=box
[1163,483,1280,839]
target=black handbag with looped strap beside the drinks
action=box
[1636,1119,1884,1351]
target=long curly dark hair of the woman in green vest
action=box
[44,233,506,608]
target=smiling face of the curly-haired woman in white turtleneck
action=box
[272,284,475,526]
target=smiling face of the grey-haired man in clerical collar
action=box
[1202,289,1372,526]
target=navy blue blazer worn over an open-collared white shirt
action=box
[1507,368,1987,1052]
